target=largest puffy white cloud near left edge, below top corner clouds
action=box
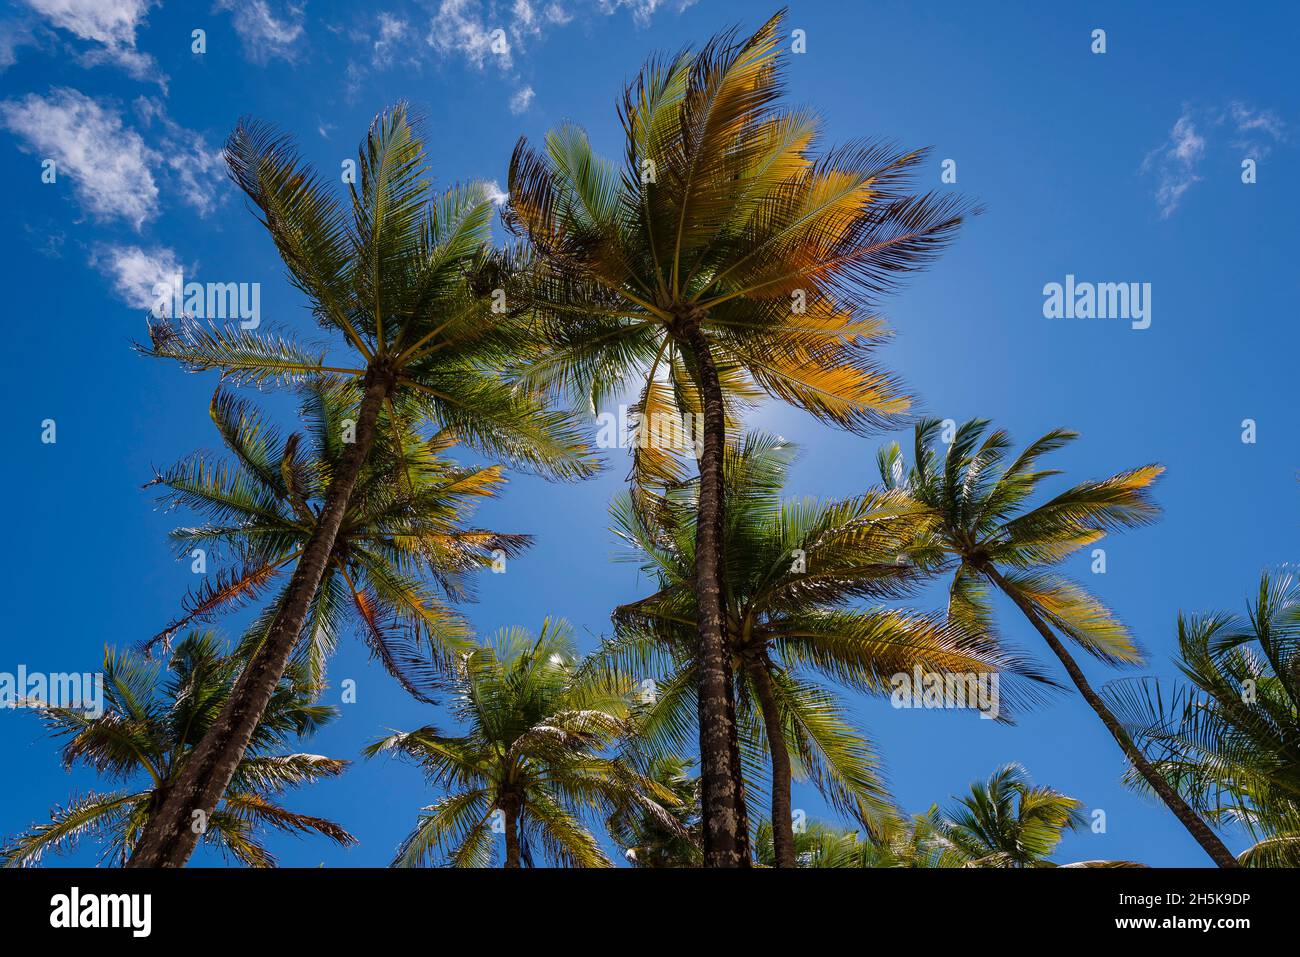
[0,88,159,229]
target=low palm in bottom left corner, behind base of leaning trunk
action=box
[0,632,356,867]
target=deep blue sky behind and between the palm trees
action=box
[0,0,1300,866]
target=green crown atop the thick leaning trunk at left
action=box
[146,105,592,477]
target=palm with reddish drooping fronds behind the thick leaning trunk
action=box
[143,380,530,701]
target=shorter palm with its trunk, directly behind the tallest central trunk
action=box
[606,434,1036,867]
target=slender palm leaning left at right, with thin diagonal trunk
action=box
[878,419,1236,867]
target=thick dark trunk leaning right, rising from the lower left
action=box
[126,369,394,867]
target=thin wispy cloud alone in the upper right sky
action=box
[1141,100,1287,218]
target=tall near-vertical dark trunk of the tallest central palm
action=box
[679,316,749,867]
